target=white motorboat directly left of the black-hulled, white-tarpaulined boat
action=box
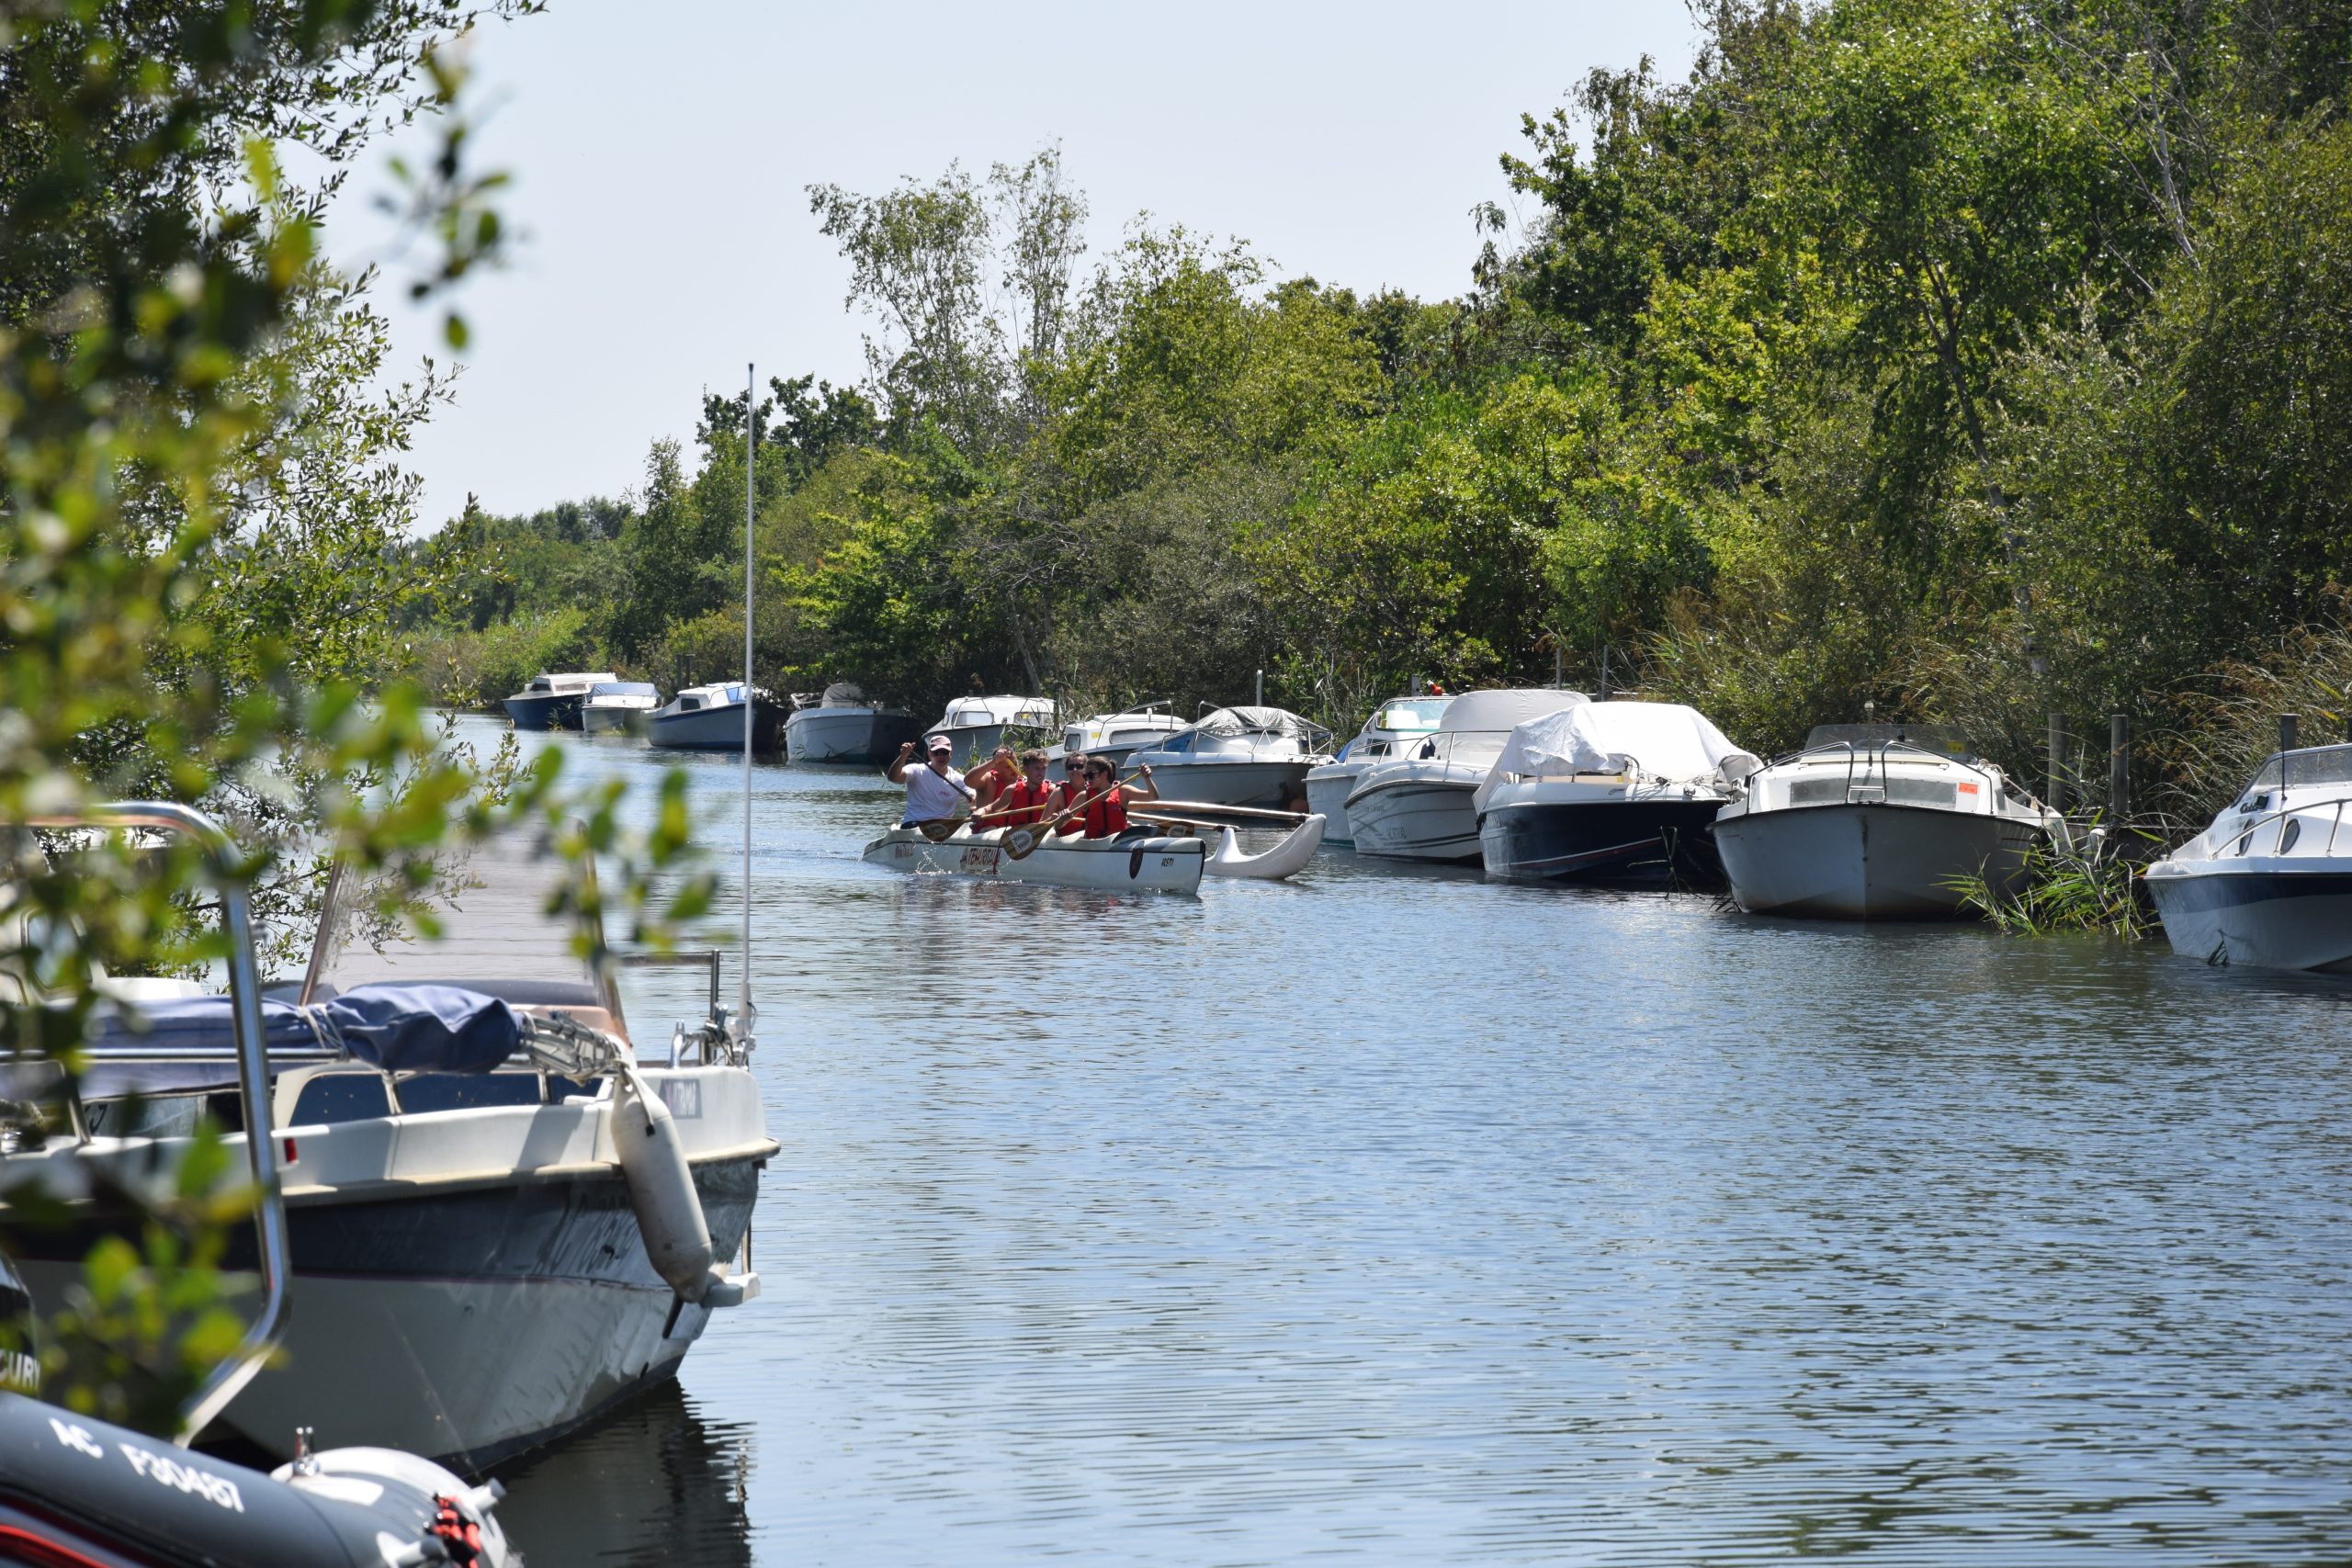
[1348,689,1588,863]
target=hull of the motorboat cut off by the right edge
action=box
[2147,858,2352,974]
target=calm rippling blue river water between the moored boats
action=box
[466,719,2352,1565]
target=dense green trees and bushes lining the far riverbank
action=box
[424,0,2352,831]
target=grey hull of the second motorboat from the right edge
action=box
[1714,804,2041,919]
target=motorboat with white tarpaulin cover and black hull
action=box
[1473,701,1764,884]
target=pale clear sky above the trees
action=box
[329,0,1696,526]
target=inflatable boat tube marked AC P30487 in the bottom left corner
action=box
[0,1394,522,1568]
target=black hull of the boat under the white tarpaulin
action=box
[1479,797,1724,886]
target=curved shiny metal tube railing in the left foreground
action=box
[24,802,289,1448]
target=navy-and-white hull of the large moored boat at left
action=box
[18,1145,774,1472]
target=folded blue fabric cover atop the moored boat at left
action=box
[65,985,522,1098]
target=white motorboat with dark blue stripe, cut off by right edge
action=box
[2147,745,2352,974]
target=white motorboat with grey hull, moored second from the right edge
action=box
[1714,724,2061,919]
